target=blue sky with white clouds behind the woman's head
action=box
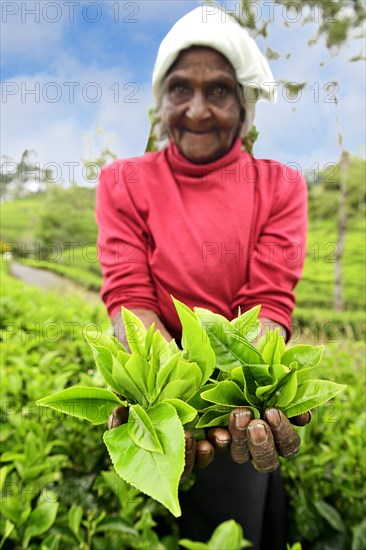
[1,0,365,185]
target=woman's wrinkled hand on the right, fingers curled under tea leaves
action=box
[207,407,311,472]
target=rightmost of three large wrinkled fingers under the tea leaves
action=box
[264,409,301,458]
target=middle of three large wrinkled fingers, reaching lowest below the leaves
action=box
[247,420,280,473]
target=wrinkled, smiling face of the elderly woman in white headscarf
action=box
[160,46,243,164]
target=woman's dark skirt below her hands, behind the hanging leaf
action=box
[178,452,287,550]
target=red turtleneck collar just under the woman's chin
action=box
[166,138,242,184]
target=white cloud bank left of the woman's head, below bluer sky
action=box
[2,56,151,184]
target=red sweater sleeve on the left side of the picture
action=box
[96,162,159,317]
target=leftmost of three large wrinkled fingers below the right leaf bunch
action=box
[228,409,253,464]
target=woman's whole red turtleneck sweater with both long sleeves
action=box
[96,139,307,337]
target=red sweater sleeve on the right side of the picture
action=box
[233,165,307,335]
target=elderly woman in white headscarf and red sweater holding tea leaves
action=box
[97,6,310,550]
